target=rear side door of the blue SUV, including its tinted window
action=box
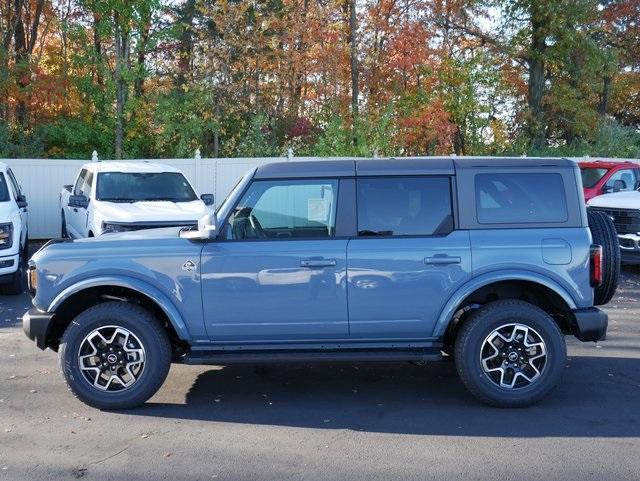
[347,175,471,340]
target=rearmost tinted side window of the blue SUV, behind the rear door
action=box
[475,173,567,224]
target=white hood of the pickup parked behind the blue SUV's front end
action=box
[94,200,208,222]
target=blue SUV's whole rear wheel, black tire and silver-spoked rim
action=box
[455,300,567,407]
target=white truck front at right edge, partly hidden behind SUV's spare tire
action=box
[587,190,640,264]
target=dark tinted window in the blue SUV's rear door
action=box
[358,177,453,236]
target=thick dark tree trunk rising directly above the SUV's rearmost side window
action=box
[527,2,547,150]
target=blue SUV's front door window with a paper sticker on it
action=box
[227,180,338,239]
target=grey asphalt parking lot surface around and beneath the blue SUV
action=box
[0,269,640,481]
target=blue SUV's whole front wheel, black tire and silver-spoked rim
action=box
[58,301,171,410]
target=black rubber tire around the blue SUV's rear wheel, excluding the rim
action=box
[455,300,567,408]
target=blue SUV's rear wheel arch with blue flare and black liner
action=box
[434,272,578,342]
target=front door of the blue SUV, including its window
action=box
[201,179,349,343]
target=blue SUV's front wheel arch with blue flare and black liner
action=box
[47,277,191,347]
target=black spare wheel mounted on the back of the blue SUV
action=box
[587,209,620,306]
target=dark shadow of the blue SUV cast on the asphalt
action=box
[127,357,640,437]
